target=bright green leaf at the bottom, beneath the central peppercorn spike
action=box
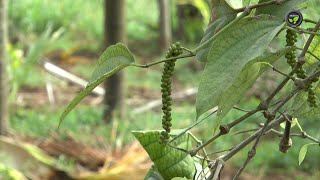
[132,131,196,179]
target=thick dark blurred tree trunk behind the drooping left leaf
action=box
[103,0,126,123]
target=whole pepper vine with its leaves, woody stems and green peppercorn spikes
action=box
[59,0,320,179]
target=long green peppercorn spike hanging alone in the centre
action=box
[160,42,182,143]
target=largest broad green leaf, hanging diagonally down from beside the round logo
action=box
[196,15,284,117]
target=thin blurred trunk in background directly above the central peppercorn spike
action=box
[158,0,172,52]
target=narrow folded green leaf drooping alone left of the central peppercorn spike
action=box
[59,43,135,125]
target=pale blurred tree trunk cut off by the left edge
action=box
[0,0,9,135]
